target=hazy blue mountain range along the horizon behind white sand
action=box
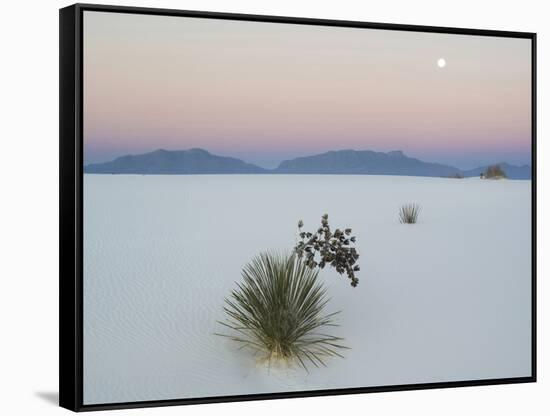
[84,149,531,179]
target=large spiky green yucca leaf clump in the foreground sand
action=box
[217,252,346,370]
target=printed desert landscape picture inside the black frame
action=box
[83,11,533,405]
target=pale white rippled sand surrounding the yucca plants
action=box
[84,175,531,404]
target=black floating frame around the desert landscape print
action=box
[59,4,537,411]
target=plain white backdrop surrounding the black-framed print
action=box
[0,0,550,416]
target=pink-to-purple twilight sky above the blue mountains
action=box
[84,11,531,168]
